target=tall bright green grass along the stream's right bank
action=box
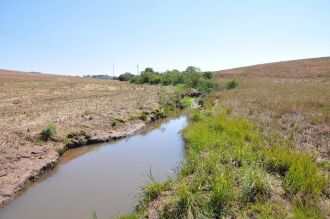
[120,110,328,218]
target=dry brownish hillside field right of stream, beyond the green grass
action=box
[214,57,330,159]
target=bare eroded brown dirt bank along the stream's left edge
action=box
[0,114,160,207]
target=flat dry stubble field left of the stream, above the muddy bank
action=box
[0,70,173,150]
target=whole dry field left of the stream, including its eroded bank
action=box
[0,70,179,206]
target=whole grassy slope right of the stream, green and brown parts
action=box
[122,58,330,218]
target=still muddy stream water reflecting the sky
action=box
[0,115,187,219]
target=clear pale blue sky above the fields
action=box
[0,0,330,75]
